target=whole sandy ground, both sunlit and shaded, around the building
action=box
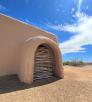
[0,65,92,102]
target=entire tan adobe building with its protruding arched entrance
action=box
[0,14,63,84]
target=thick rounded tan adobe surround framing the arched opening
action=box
[18,36,63,83]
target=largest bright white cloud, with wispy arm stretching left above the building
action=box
[47,13,92,54]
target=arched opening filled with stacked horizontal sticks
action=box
[34,44,55,80]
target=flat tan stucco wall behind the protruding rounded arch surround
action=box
[0,14,61,83]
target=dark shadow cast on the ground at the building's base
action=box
[0,75,60,94]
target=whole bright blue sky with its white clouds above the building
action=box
[0,0,92,62]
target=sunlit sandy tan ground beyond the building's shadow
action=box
[0,66,92,102]
